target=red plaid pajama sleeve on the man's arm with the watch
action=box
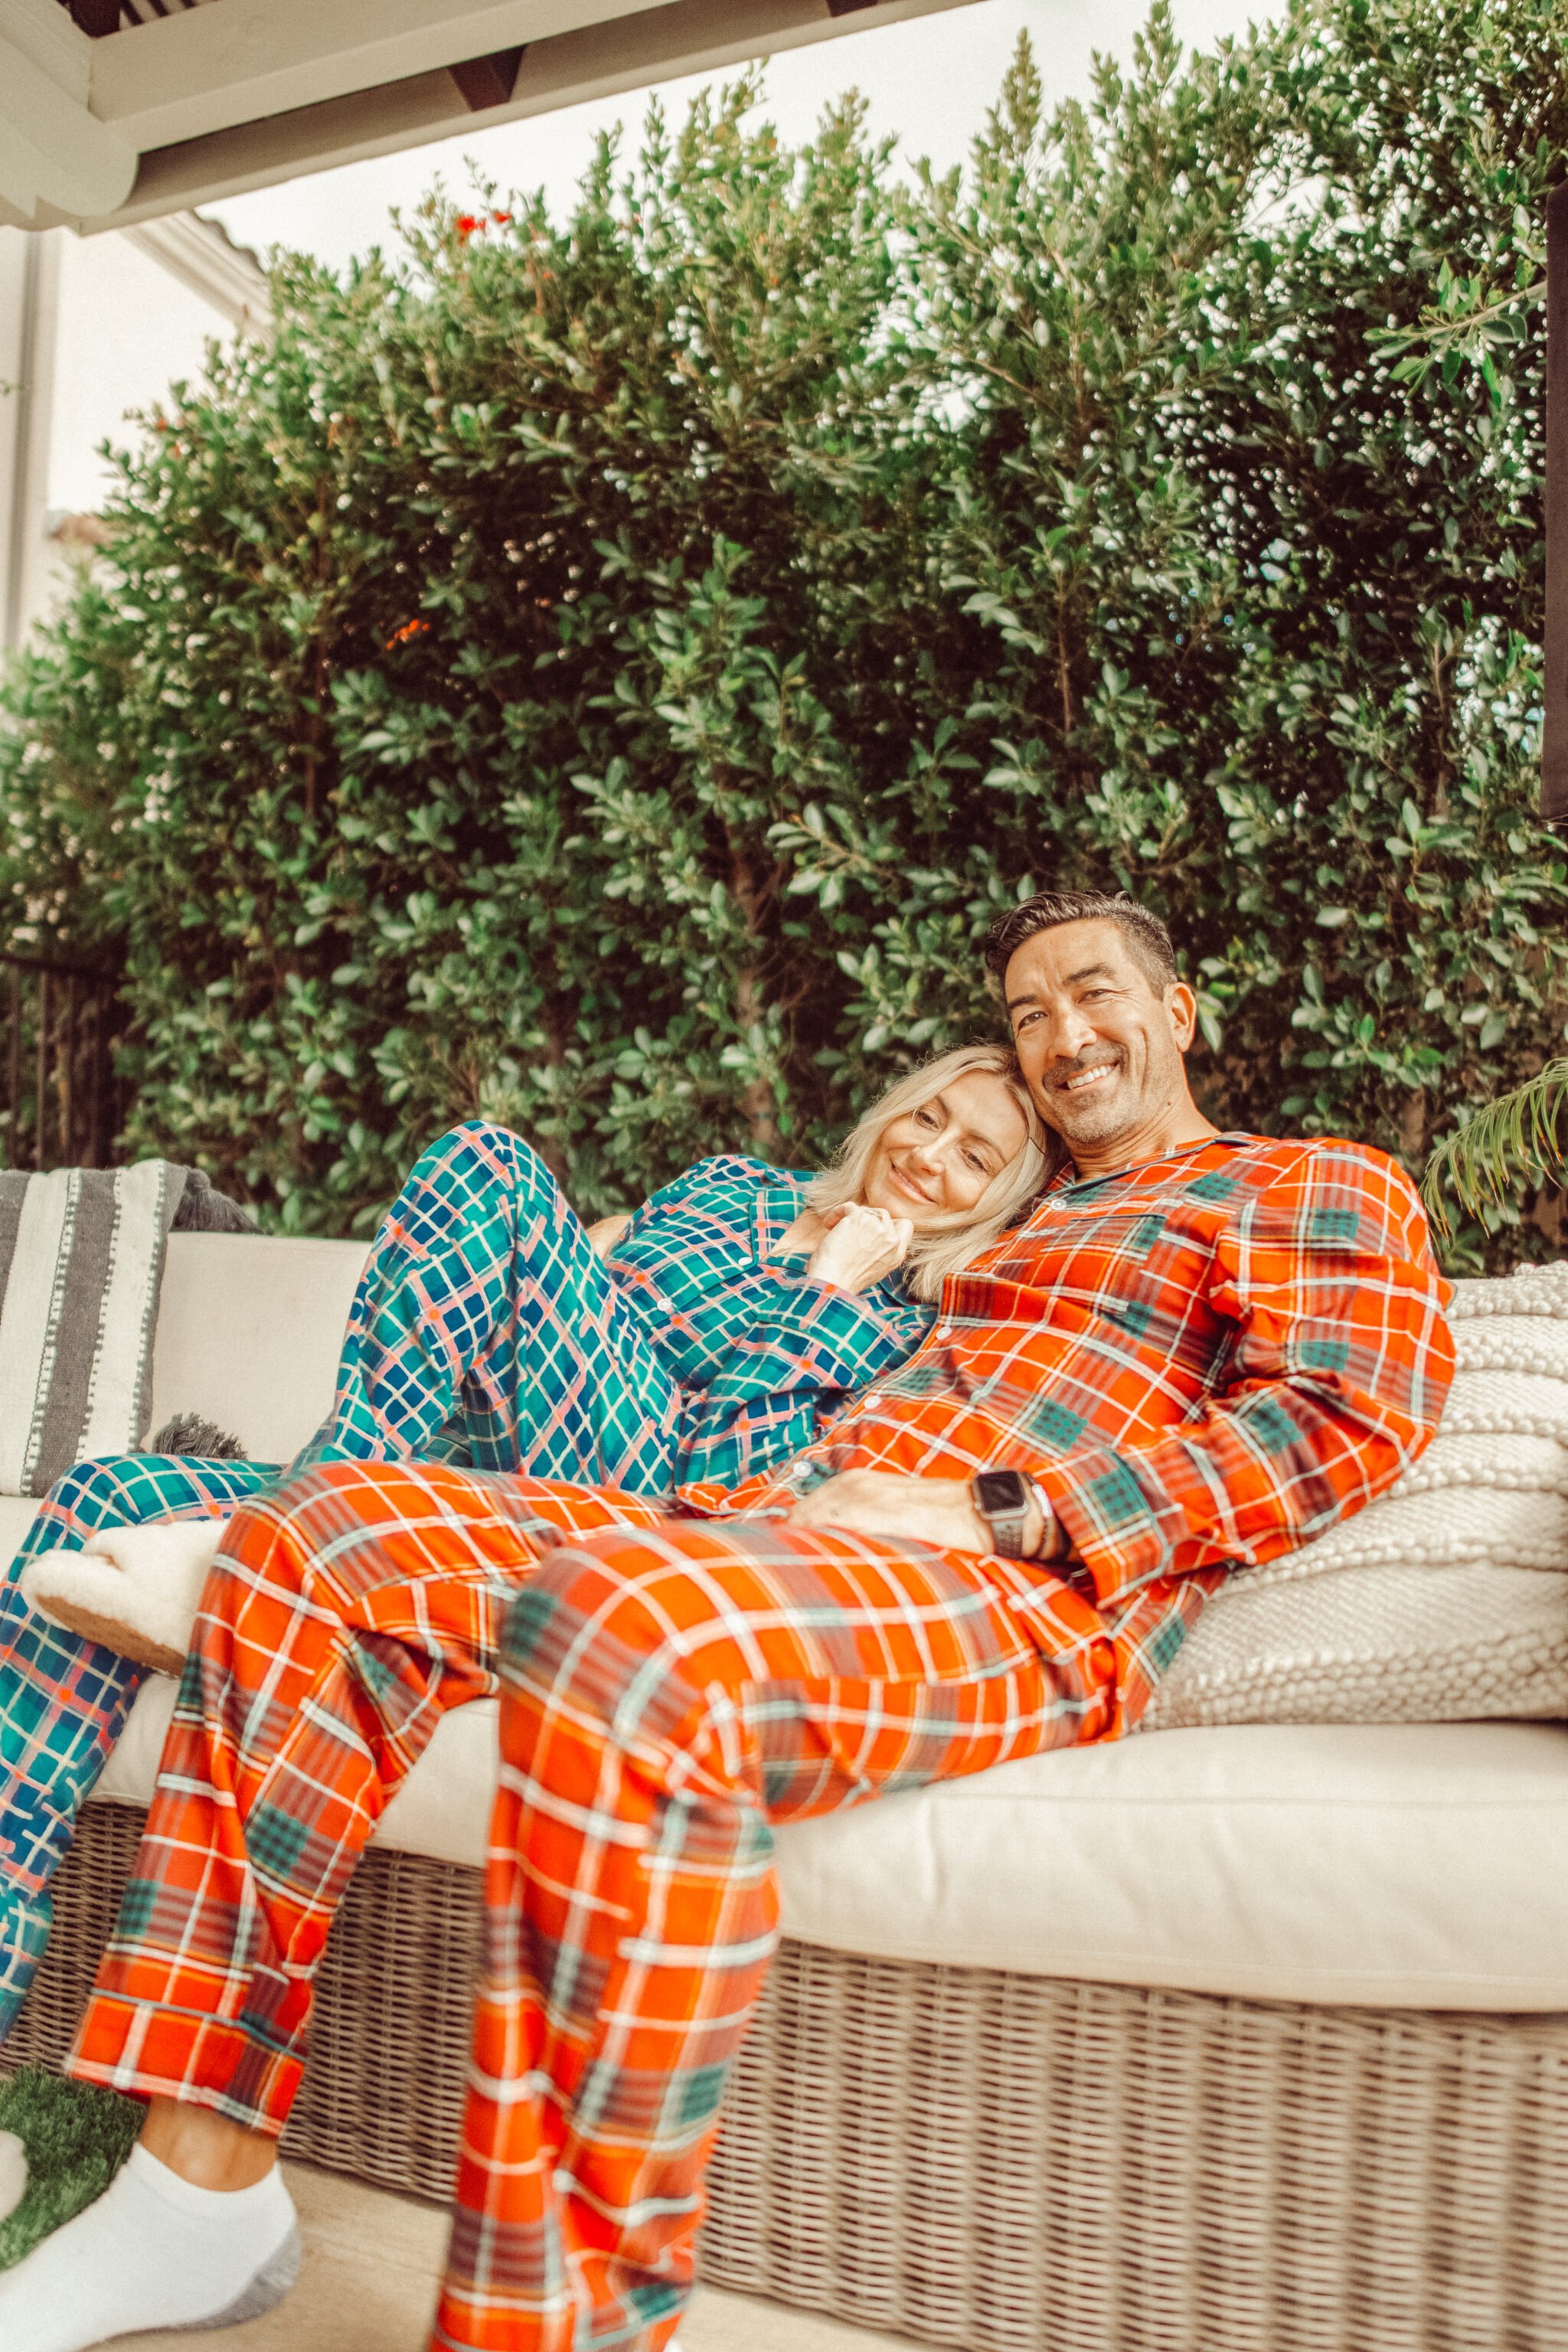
[1029,1145,1453,1604]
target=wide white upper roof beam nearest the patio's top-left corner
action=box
[88,0,672,151]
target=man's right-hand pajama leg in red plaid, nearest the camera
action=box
[433,1522,1112,2352]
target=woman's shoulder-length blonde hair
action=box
[806,1044,1054,1301]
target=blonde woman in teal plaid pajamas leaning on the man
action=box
[0,1047,1044,2037]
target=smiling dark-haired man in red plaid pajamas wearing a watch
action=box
[0,893,1453,2352]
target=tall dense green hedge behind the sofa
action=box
[0,0,1568,1251]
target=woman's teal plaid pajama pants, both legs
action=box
[0,1124,681,2039]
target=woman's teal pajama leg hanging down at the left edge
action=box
[0,1453,277,2039]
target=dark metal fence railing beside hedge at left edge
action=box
[0,950,125,1169]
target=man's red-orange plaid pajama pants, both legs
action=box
[70,1463,1124,2352]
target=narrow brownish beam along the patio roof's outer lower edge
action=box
[92,0,969,230]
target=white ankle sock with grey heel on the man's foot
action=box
[0,2148,299,2352]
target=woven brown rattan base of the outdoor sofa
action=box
[5,1804,1568,2352]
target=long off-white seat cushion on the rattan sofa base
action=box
[99,1679,1568,2011]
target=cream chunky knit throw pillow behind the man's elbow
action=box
[1142,1263,1568,1731]
